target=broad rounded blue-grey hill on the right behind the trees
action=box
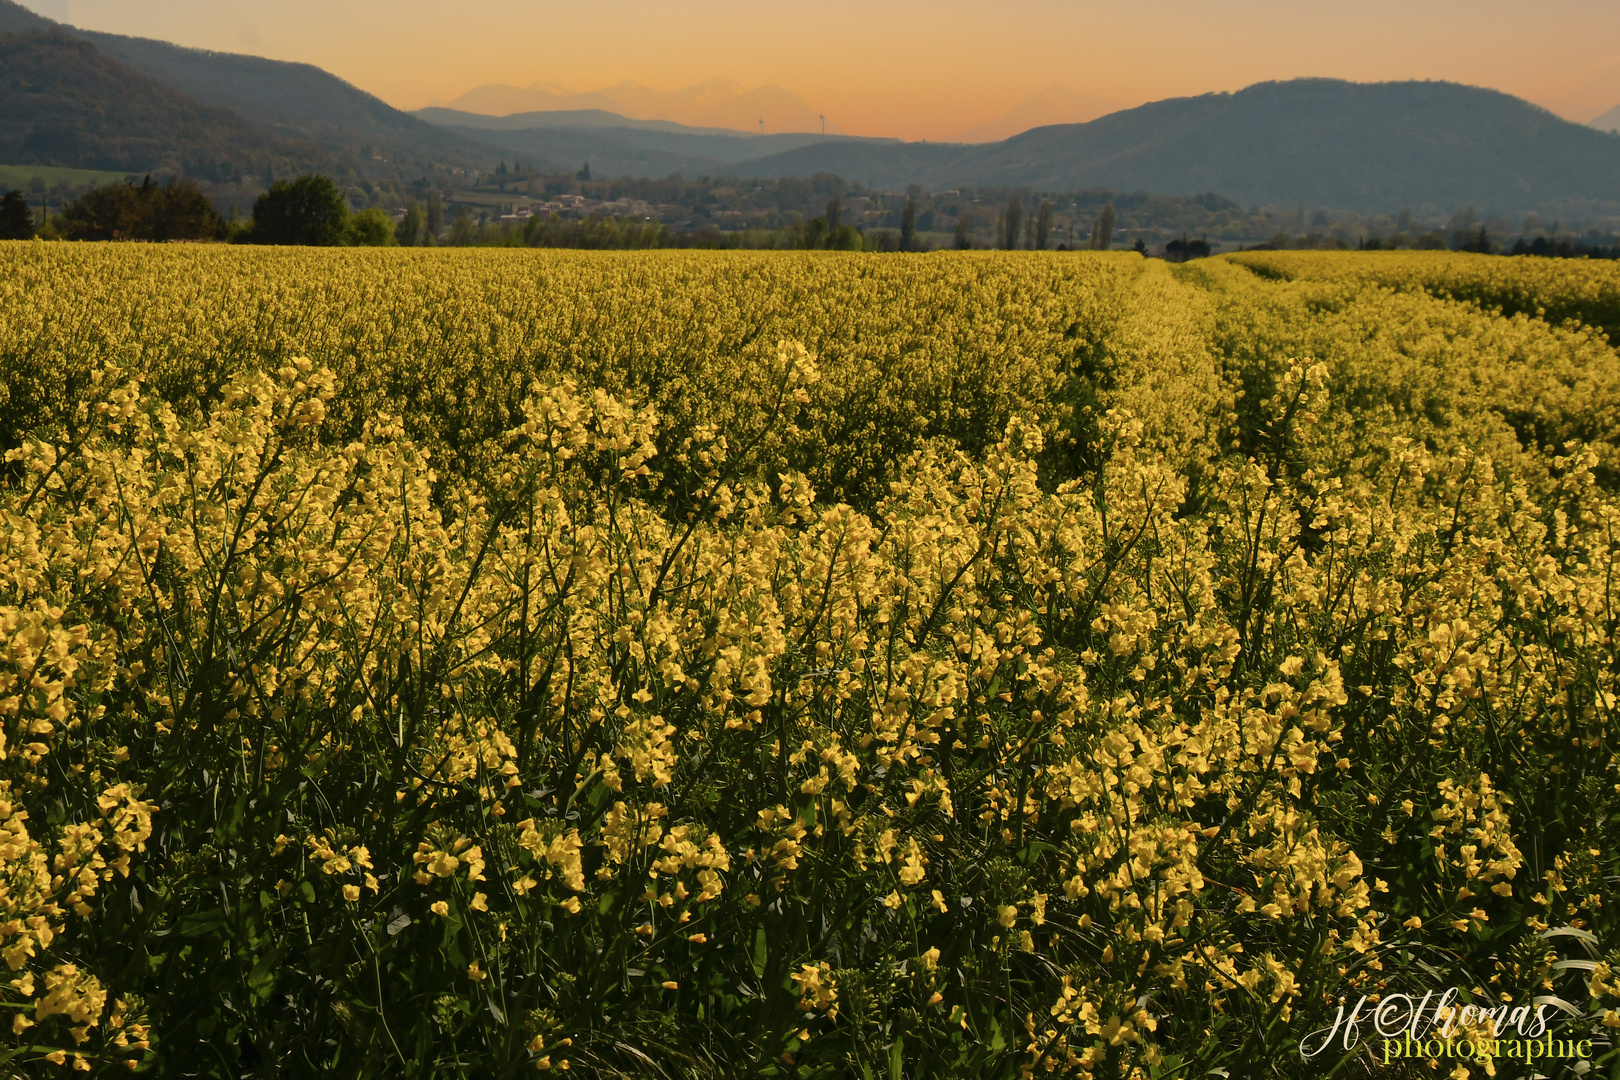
[716,79,1620,212]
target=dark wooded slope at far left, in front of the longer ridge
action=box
[0,29,335,176]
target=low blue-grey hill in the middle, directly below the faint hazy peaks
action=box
[416,108,902,176]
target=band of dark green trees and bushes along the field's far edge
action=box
[15,168,1620,261]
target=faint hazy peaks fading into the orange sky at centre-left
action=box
[449,79,842,134]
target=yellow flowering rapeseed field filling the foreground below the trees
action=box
[0,243,1620,1080]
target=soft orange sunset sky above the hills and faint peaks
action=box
[24,0,1620,139]
